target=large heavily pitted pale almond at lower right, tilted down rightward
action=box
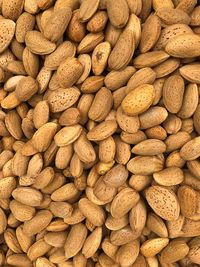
[146,185,180,221]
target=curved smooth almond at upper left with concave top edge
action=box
[25,31,56,55]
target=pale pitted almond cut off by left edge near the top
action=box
[0,18,15,53]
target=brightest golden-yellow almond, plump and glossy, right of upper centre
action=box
[122,84,155,116]
